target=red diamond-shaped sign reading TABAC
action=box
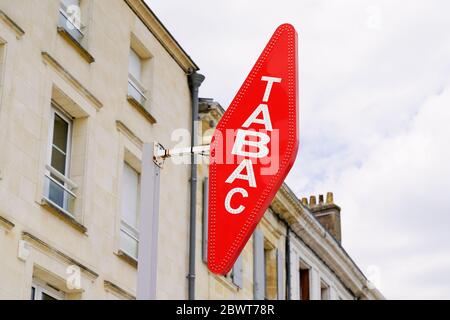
[208,24,298,274]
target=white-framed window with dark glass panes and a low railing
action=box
[44,105,77,218]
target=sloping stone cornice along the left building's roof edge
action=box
[124,0,199,73]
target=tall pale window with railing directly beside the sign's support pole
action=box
[120,163,140,259]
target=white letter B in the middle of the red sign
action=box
[231,130,270,159]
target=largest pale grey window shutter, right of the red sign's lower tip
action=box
[253,229,266,300]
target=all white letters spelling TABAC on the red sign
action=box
[225,76,282,214]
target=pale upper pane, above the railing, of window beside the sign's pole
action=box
[122,164,139,229]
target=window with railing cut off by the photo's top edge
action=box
[59,0,84,43]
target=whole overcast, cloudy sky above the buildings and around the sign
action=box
[148,0,450,299]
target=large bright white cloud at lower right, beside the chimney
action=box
[306,87,450,298]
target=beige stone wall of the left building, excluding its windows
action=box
[0,0,191,299]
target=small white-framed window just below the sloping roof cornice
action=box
[128,48,147,106]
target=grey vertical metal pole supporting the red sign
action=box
[137,143,163,300]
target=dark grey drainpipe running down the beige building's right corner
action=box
[187,72,205,300]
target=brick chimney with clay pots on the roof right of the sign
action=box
[309,192,342,243]
